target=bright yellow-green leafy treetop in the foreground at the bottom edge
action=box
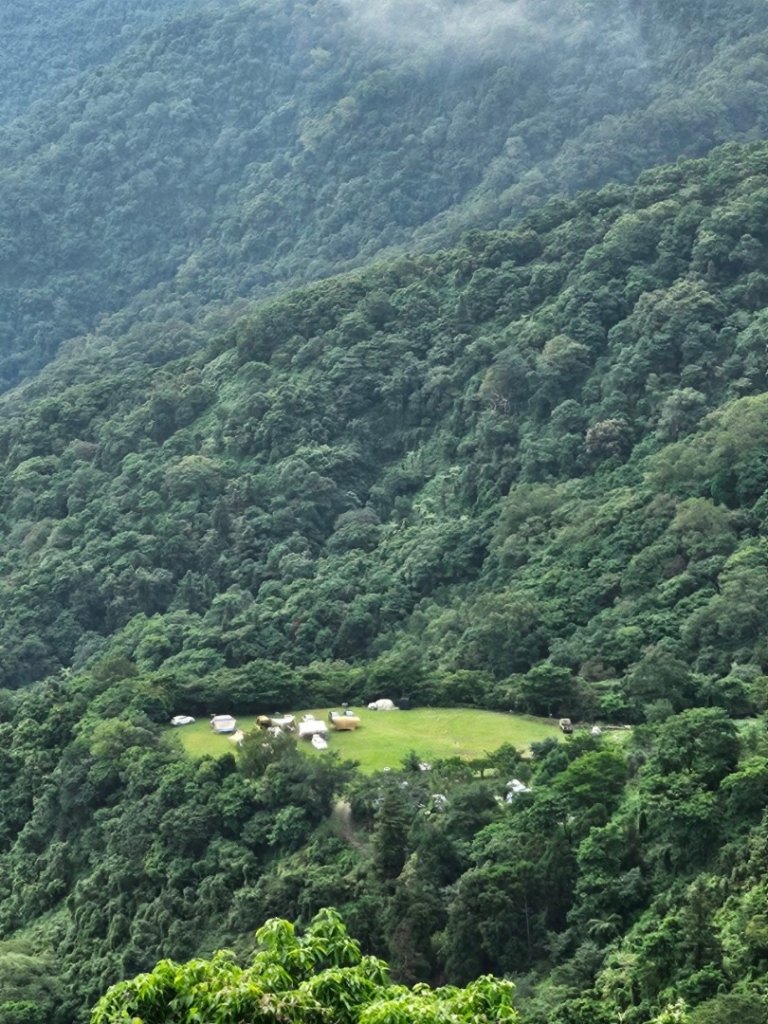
[91,908,518,1024]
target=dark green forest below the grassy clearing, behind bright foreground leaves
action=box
[0,662,768,1024]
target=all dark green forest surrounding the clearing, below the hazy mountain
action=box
[0,143,768,1024]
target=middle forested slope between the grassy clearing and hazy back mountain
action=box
[0,144,768,733]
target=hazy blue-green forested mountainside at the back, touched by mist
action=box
[0,0,768,386]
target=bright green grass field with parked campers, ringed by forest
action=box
[174,708,560,771]
